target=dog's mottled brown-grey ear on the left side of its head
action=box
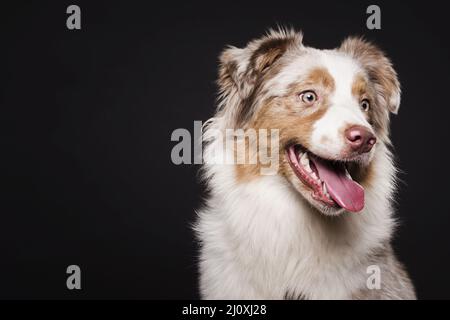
[218,29,302,99]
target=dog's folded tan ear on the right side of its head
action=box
[339,37,401,114]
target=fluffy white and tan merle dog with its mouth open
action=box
[194,28,416,300]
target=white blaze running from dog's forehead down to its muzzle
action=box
[310,51,370,158]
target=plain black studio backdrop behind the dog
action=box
[0,0,450,299]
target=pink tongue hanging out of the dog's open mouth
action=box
[310,157,364,212]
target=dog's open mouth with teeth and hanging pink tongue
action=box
[287,145,364,212]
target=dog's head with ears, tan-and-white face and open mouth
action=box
[219,31,400,215]
